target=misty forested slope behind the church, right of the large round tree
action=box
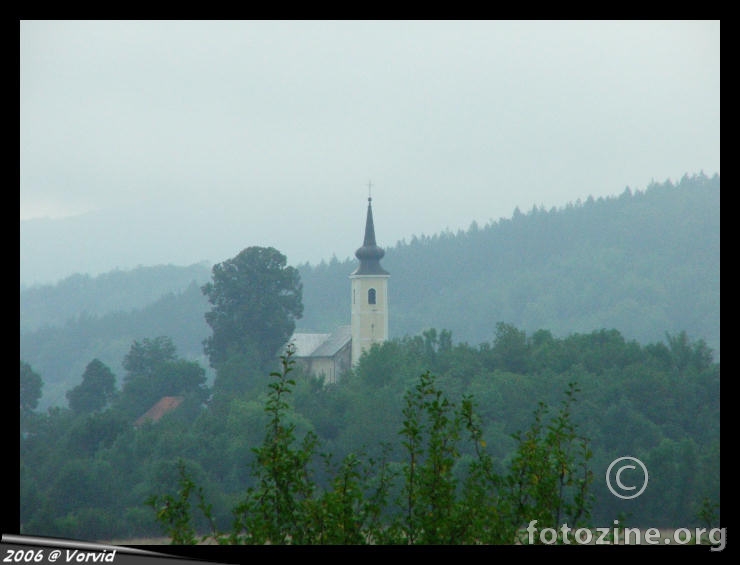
[300,170,720,354]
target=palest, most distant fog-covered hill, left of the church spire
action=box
[20,196,342,287]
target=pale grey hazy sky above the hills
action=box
[20,21,720,270]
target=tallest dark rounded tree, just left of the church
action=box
[202,247,303,369]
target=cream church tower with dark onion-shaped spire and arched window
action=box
[349,197,390,365]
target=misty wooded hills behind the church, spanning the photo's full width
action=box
[21,174,720,409]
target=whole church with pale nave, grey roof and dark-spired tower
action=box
[291,197,390,383]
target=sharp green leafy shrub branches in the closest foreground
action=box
[148,347,593,545]
